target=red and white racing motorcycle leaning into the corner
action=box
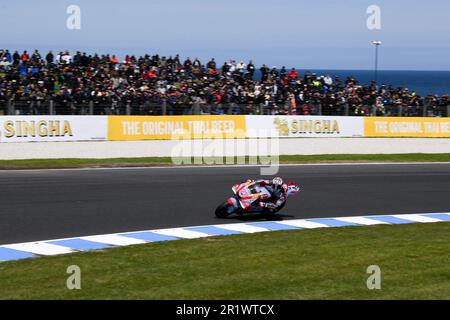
[215,180,300,218]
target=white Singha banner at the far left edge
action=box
[0,116,107,143]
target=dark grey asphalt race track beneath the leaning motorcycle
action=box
[0,164,450,244]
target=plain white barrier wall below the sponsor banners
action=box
[0,138,450,160]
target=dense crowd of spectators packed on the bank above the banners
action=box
[0,49,450,116]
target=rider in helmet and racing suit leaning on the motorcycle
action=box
[248,177,288,212]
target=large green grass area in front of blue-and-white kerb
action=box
[0,223,450,299]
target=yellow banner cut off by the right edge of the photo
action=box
[364,117,450,138]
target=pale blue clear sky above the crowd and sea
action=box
[0,0,450,70]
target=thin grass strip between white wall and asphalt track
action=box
[0,153,450,170]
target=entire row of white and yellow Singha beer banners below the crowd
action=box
[0,115,450,143]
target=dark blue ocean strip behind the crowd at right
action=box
[256,69,450,96]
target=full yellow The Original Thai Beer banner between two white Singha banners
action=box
[108,115,246,141]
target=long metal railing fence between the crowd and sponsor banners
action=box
[0,99,450,117]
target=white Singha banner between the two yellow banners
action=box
[246,116,364,138]
